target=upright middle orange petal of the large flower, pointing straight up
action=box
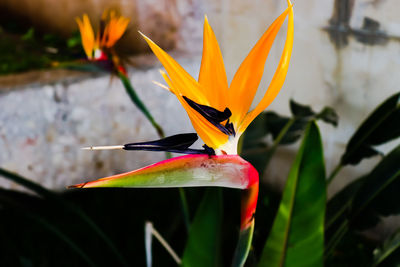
[199,17,228,110]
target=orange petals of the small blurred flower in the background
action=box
[76,10,129,60]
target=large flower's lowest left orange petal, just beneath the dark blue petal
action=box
[161,71,228,149]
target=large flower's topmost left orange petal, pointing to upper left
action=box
[140,33,210,106]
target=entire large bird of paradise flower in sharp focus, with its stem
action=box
[71,0,294,266]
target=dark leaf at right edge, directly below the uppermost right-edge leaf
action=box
[351,145,400,229]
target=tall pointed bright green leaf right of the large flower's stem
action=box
[259,121,326,267]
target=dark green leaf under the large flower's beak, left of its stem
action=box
[182,188,223,267]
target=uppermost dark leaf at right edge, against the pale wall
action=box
[340,92,400,165]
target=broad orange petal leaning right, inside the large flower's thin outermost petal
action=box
[229,8,290,125]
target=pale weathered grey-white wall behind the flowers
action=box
[0,0,400,199]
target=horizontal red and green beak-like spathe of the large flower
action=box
[70,154,258,189]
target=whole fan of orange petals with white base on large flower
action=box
[142,0,293,154]
